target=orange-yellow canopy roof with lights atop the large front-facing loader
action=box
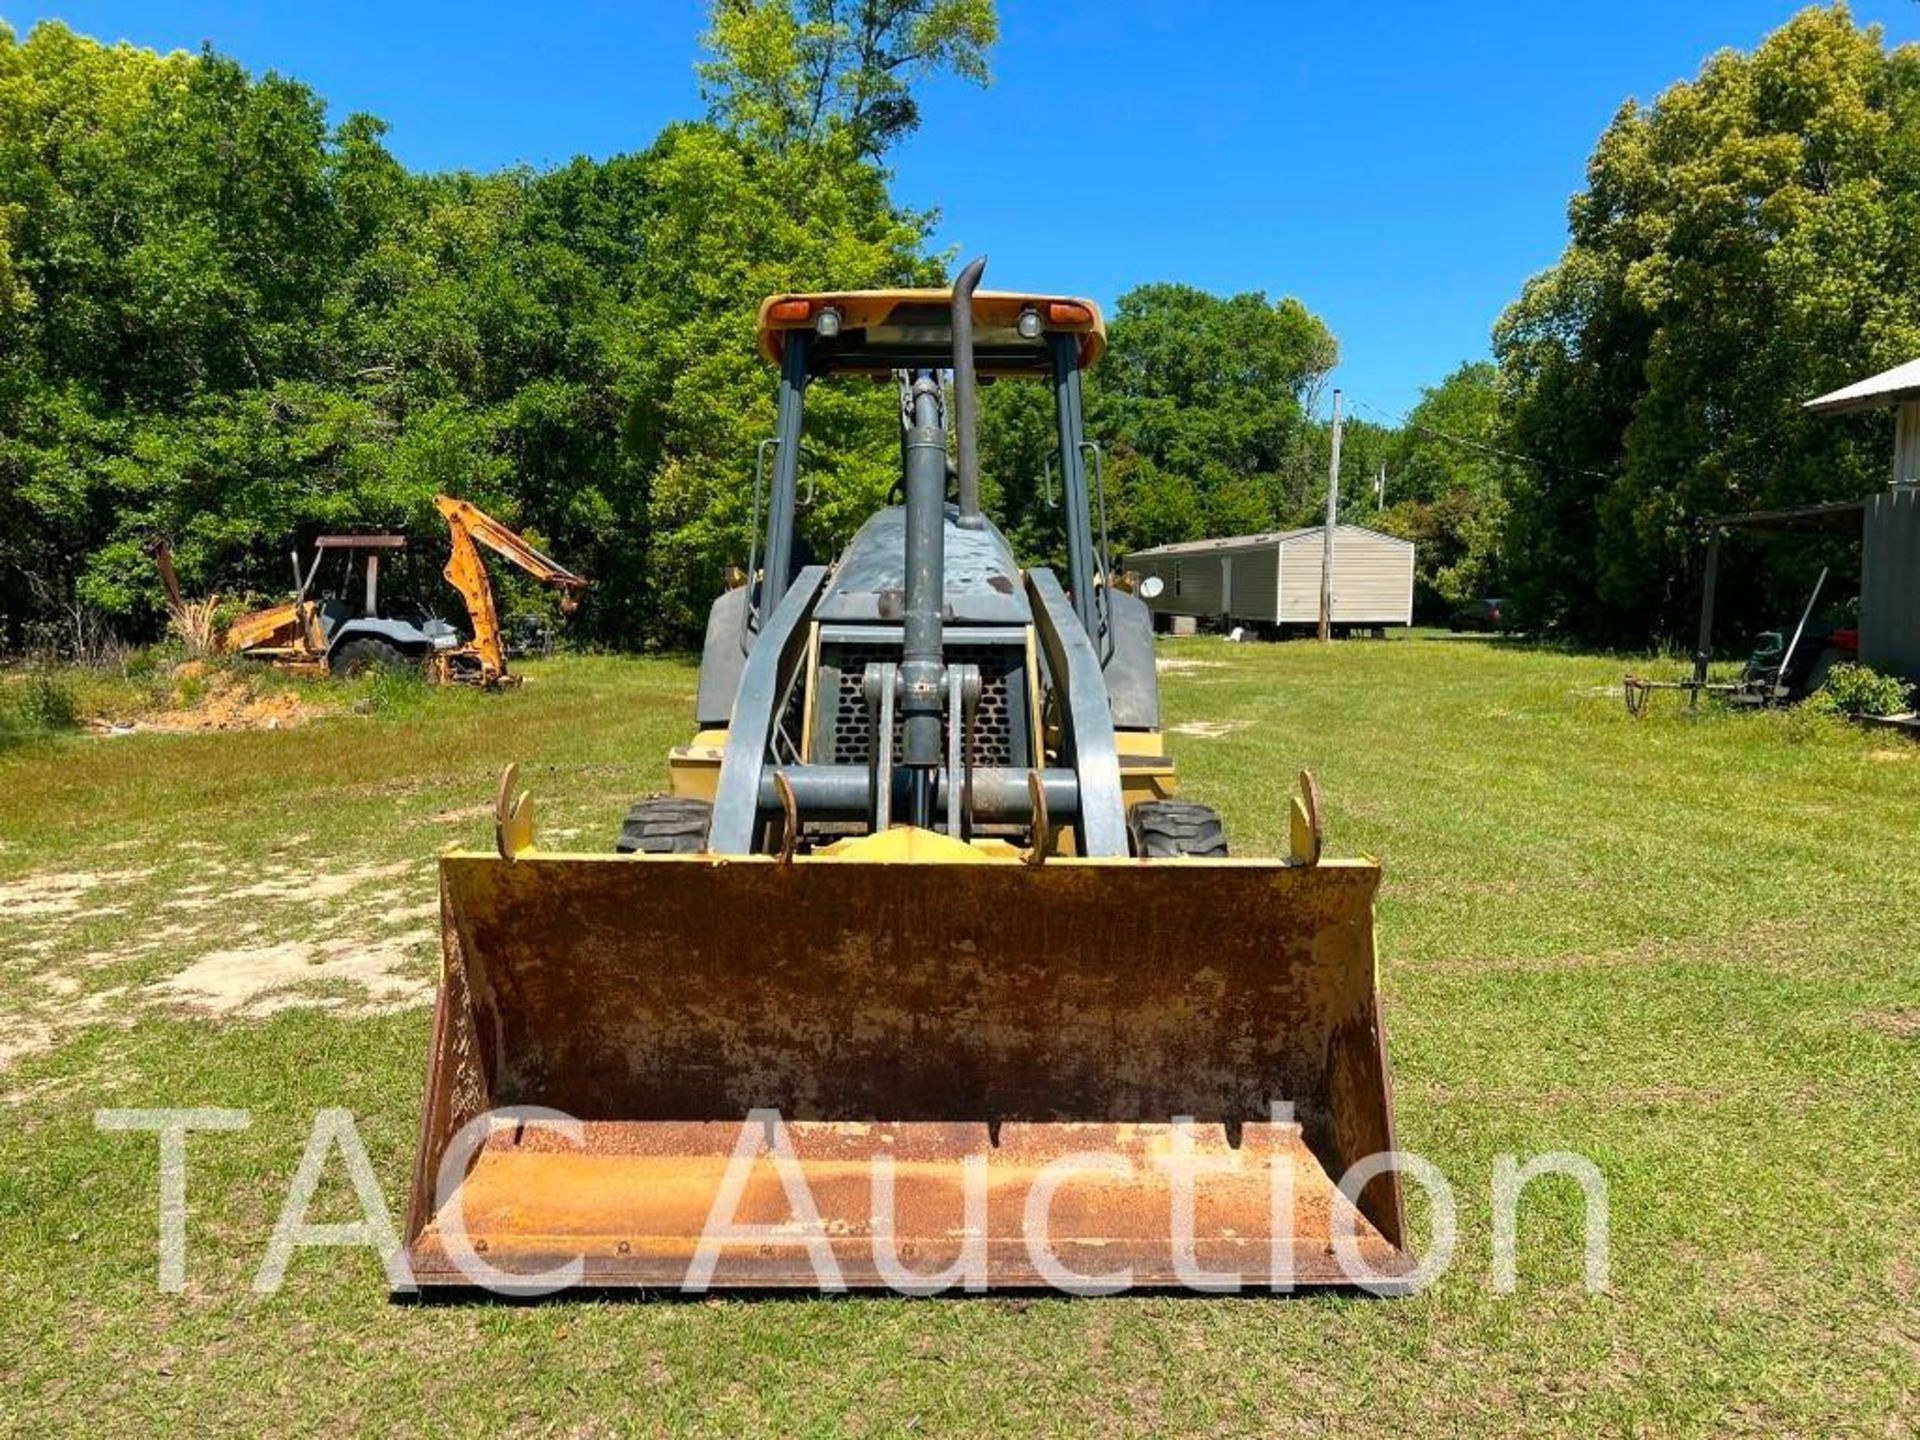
[760,290,1106,378]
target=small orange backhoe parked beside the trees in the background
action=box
[152,495,588,689]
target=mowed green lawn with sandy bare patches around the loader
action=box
[0,637,1920,1436]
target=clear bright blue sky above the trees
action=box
[11,0,1920,419]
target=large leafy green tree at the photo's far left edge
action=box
[0,25,397,641]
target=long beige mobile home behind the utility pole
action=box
[1125,524,1413,630]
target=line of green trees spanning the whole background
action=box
[0,0,1920,649]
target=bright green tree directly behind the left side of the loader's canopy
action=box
[622,127,941,636]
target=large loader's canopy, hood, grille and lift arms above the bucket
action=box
[676,272,1171,854]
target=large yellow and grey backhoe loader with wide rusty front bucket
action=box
[401,261,1413,1294]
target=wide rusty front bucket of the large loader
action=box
[407,852,1411,1292]
